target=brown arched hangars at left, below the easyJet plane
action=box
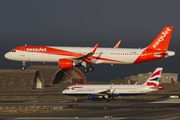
[0,65,87,90]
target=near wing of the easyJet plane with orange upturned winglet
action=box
[74,43,99,64]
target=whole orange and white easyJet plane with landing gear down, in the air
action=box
[5,26,175,73]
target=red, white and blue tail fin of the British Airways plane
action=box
[144,68,163,87]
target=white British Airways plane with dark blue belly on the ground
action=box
[62,68,164,101]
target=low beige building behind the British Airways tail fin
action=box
[129,72,178,84]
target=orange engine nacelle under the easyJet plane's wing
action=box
[59,59,74,69]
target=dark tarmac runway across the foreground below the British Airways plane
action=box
[0,98,180,120]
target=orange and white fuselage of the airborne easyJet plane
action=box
[5,46,174,64]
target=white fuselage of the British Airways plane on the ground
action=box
[62,85,158,96]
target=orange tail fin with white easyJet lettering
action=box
[147,26,173,51]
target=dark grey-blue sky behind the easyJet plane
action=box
[0,0,180,82]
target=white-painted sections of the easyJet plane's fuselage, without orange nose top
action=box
[5,47,143,64]
